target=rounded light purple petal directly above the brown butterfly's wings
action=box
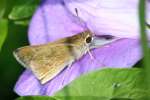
[29,0,84,44]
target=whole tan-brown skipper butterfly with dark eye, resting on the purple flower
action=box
[14,31,118,84]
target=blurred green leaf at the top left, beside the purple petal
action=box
[9,0,40,20]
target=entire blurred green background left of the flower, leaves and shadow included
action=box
[0,0,39,100]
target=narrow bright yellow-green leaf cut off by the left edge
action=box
[0,19,8,51]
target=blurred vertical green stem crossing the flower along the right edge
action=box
[139,0,150,89]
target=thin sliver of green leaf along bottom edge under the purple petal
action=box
[16,96,56,100]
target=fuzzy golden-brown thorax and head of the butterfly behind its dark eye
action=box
[54,30,92,59]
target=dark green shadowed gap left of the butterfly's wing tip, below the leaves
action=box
[0,21,27,100]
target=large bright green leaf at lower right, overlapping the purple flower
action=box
[55,68,149,100]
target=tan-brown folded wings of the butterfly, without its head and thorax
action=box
[14,44,75,84]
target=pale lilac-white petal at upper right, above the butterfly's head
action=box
[65,0,150,39]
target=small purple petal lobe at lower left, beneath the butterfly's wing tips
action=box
[15,70,42,96]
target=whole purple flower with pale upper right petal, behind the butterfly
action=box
[14,0,150,96]
